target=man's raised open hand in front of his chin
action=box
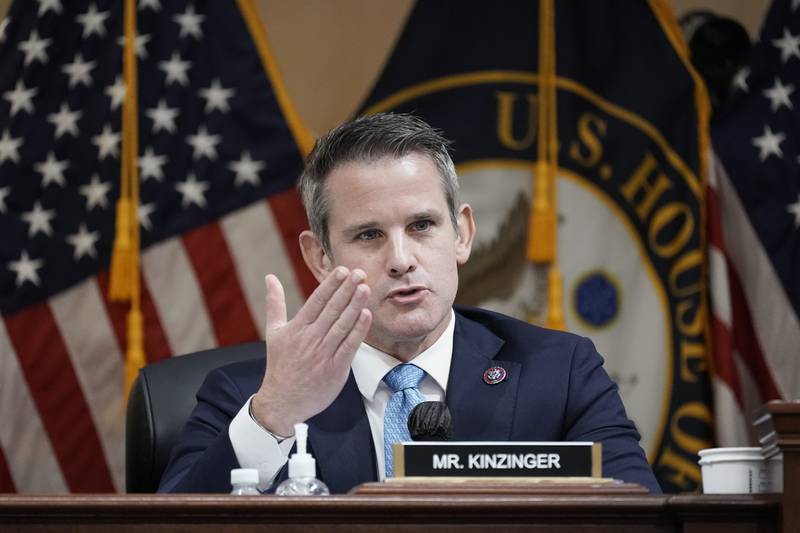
[251,266,372,436]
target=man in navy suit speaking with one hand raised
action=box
[160,114,659,492]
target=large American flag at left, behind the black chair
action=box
[0,0,314,492]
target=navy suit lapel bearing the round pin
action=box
[447,313,521,441]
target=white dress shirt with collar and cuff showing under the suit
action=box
[228,311,455,491]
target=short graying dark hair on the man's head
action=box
[297,113,458,254]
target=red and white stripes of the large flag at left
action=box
[0,190,316,492]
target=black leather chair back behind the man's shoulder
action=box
[125,342,264,492]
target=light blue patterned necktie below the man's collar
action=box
[383,364,425,478]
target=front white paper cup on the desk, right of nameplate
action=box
[698,448,770,494]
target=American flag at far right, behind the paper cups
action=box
[708,0,800,446]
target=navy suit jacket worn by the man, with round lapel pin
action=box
[159,308,660,493]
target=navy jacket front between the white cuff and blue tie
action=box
[308,371,378,493]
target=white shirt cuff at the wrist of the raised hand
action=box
[228,396,295,491]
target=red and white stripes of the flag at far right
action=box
[707,157,800,446]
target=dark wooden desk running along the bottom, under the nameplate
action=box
[0,494,781,533]
